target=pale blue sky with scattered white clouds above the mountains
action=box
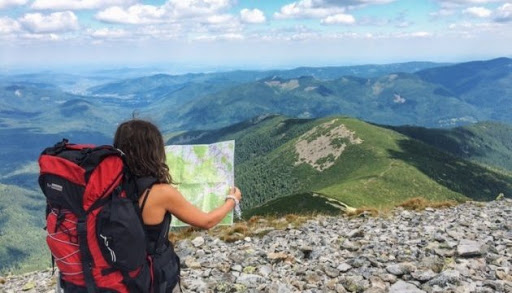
[0,0,512,71]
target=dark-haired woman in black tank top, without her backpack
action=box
[114,119,242,292]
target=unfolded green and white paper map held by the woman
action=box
[165,140,235,227]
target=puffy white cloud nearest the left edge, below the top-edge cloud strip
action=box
[19,11,79,33]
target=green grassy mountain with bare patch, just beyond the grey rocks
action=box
[168,115,512,214]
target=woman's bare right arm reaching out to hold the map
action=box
[158,185,242,229]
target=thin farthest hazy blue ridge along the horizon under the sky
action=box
[89,62,443,105]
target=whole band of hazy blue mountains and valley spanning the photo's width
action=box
[4,58,512,135]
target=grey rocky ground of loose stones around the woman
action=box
[0,199,512,293]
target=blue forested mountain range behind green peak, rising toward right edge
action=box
[142,58,512,130]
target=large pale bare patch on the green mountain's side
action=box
[295,119,363,172]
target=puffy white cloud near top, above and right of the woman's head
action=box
[96,4,166,24]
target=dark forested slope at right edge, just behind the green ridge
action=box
[391,122,512,171]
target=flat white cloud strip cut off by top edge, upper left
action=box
[30,0,134,10]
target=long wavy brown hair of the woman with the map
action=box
[114,119,172,183]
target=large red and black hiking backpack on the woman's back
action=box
[39,139,156,293]
